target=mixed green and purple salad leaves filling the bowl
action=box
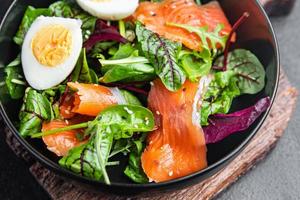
[1,0,270,184]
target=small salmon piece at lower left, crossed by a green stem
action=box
[42,120,86,156]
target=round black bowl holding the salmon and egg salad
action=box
[0,0,280,195]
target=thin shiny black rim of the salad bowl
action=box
[0,0,280,189]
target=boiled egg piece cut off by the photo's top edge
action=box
[76,0,139,20]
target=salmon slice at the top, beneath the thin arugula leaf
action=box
[132,0,235,51]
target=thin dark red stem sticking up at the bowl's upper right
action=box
[222,12,250,71]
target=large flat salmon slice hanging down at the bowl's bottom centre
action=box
[142,80,207,182]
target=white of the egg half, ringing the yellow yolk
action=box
[21,16,83,90]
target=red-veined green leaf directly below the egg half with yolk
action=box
[19,88,54,137]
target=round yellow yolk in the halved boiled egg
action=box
[31,24,72,67]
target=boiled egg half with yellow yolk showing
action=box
[21,16,83,90]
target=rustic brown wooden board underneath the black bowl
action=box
[2,73,298,200]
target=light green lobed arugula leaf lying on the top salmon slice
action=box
[167,23,228,55]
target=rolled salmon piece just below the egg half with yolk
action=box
[60,82,126,119]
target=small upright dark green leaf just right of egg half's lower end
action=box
[71,49,92,83]
